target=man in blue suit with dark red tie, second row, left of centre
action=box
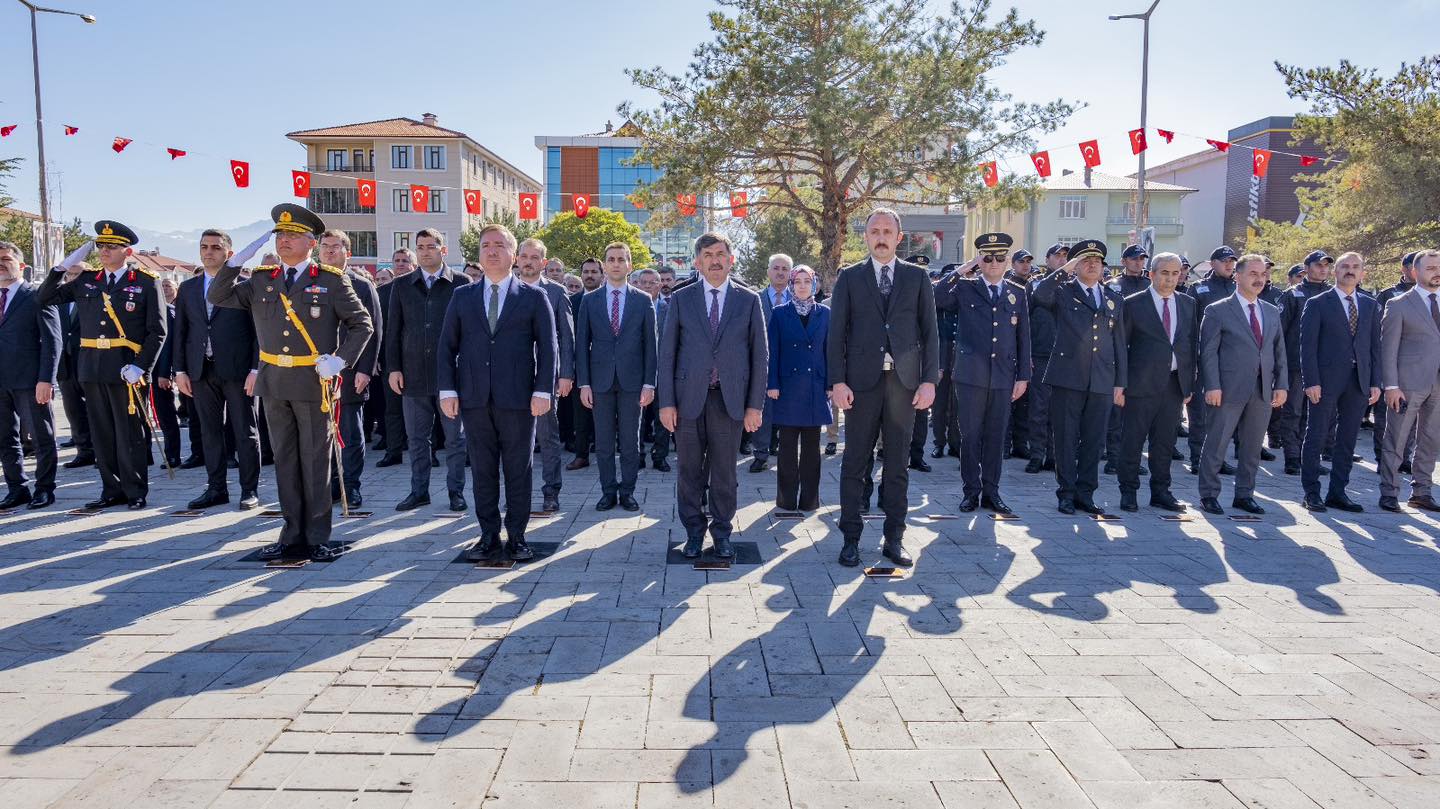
[575,242,659,511]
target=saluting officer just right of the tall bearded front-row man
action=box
[936,233,1031,514]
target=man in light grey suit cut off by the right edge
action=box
[1380,250,1440,511]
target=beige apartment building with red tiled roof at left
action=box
[285,112,541,271]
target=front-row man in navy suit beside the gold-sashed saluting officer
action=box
[435,225,556,561]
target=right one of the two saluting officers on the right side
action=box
[1034,239,1128,514]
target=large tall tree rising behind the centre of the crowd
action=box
[621,0,1073,280]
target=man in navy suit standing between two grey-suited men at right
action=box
[1300,252,1380,512]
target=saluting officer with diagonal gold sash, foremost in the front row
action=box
[206,203,374,561]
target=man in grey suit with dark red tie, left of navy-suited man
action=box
[1200,253,1290,514]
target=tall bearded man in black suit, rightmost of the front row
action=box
[827,209,940,567]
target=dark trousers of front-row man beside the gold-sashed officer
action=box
[459,405,536,541]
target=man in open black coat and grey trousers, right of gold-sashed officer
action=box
[384,227,469,512]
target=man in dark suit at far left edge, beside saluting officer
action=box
[0,242,60,510]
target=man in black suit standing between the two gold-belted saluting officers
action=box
[171,229,261,511]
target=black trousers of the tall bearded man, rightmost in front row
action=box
[840,371,916,543]
